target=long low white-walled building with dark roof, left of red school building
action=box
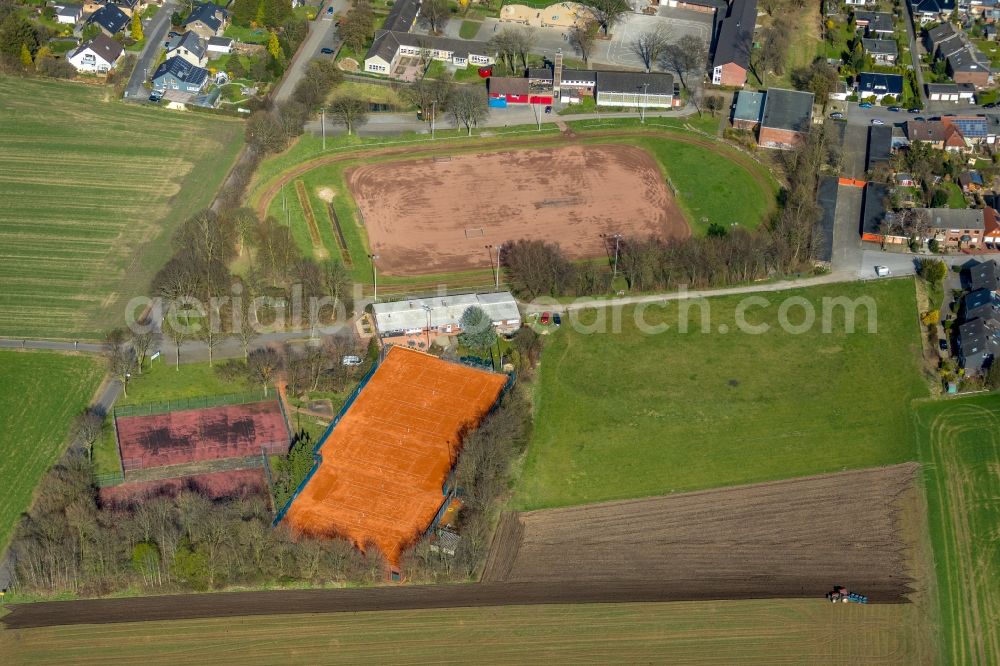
[365,30,496,79]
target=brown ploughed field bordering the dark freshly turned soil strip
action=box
[483,464,917,602]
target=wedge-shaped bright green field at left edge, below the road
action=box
[0,351,104,552]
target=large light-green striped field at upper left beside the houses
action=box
[0,77,243,339]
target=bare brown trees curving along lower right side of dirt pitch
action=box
[501,128,839,299]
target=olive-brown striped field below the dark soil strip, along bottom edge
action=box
[0,599,928,666]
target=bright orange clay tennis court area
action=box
[286,347,507,564]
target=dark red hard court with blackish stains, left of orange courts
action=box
[116,400,291,471]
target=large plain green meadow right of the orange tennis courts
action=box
[514,279,927,509]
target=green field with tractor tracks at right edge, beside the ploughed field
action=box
[914,393,1000,664]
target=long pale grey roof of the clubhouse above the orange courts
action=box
[372,291,521,335]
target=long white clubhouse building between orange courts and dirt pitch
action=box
[372,292,521,346]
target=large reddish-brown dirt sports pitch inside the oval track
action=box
[346,144,690,276]
